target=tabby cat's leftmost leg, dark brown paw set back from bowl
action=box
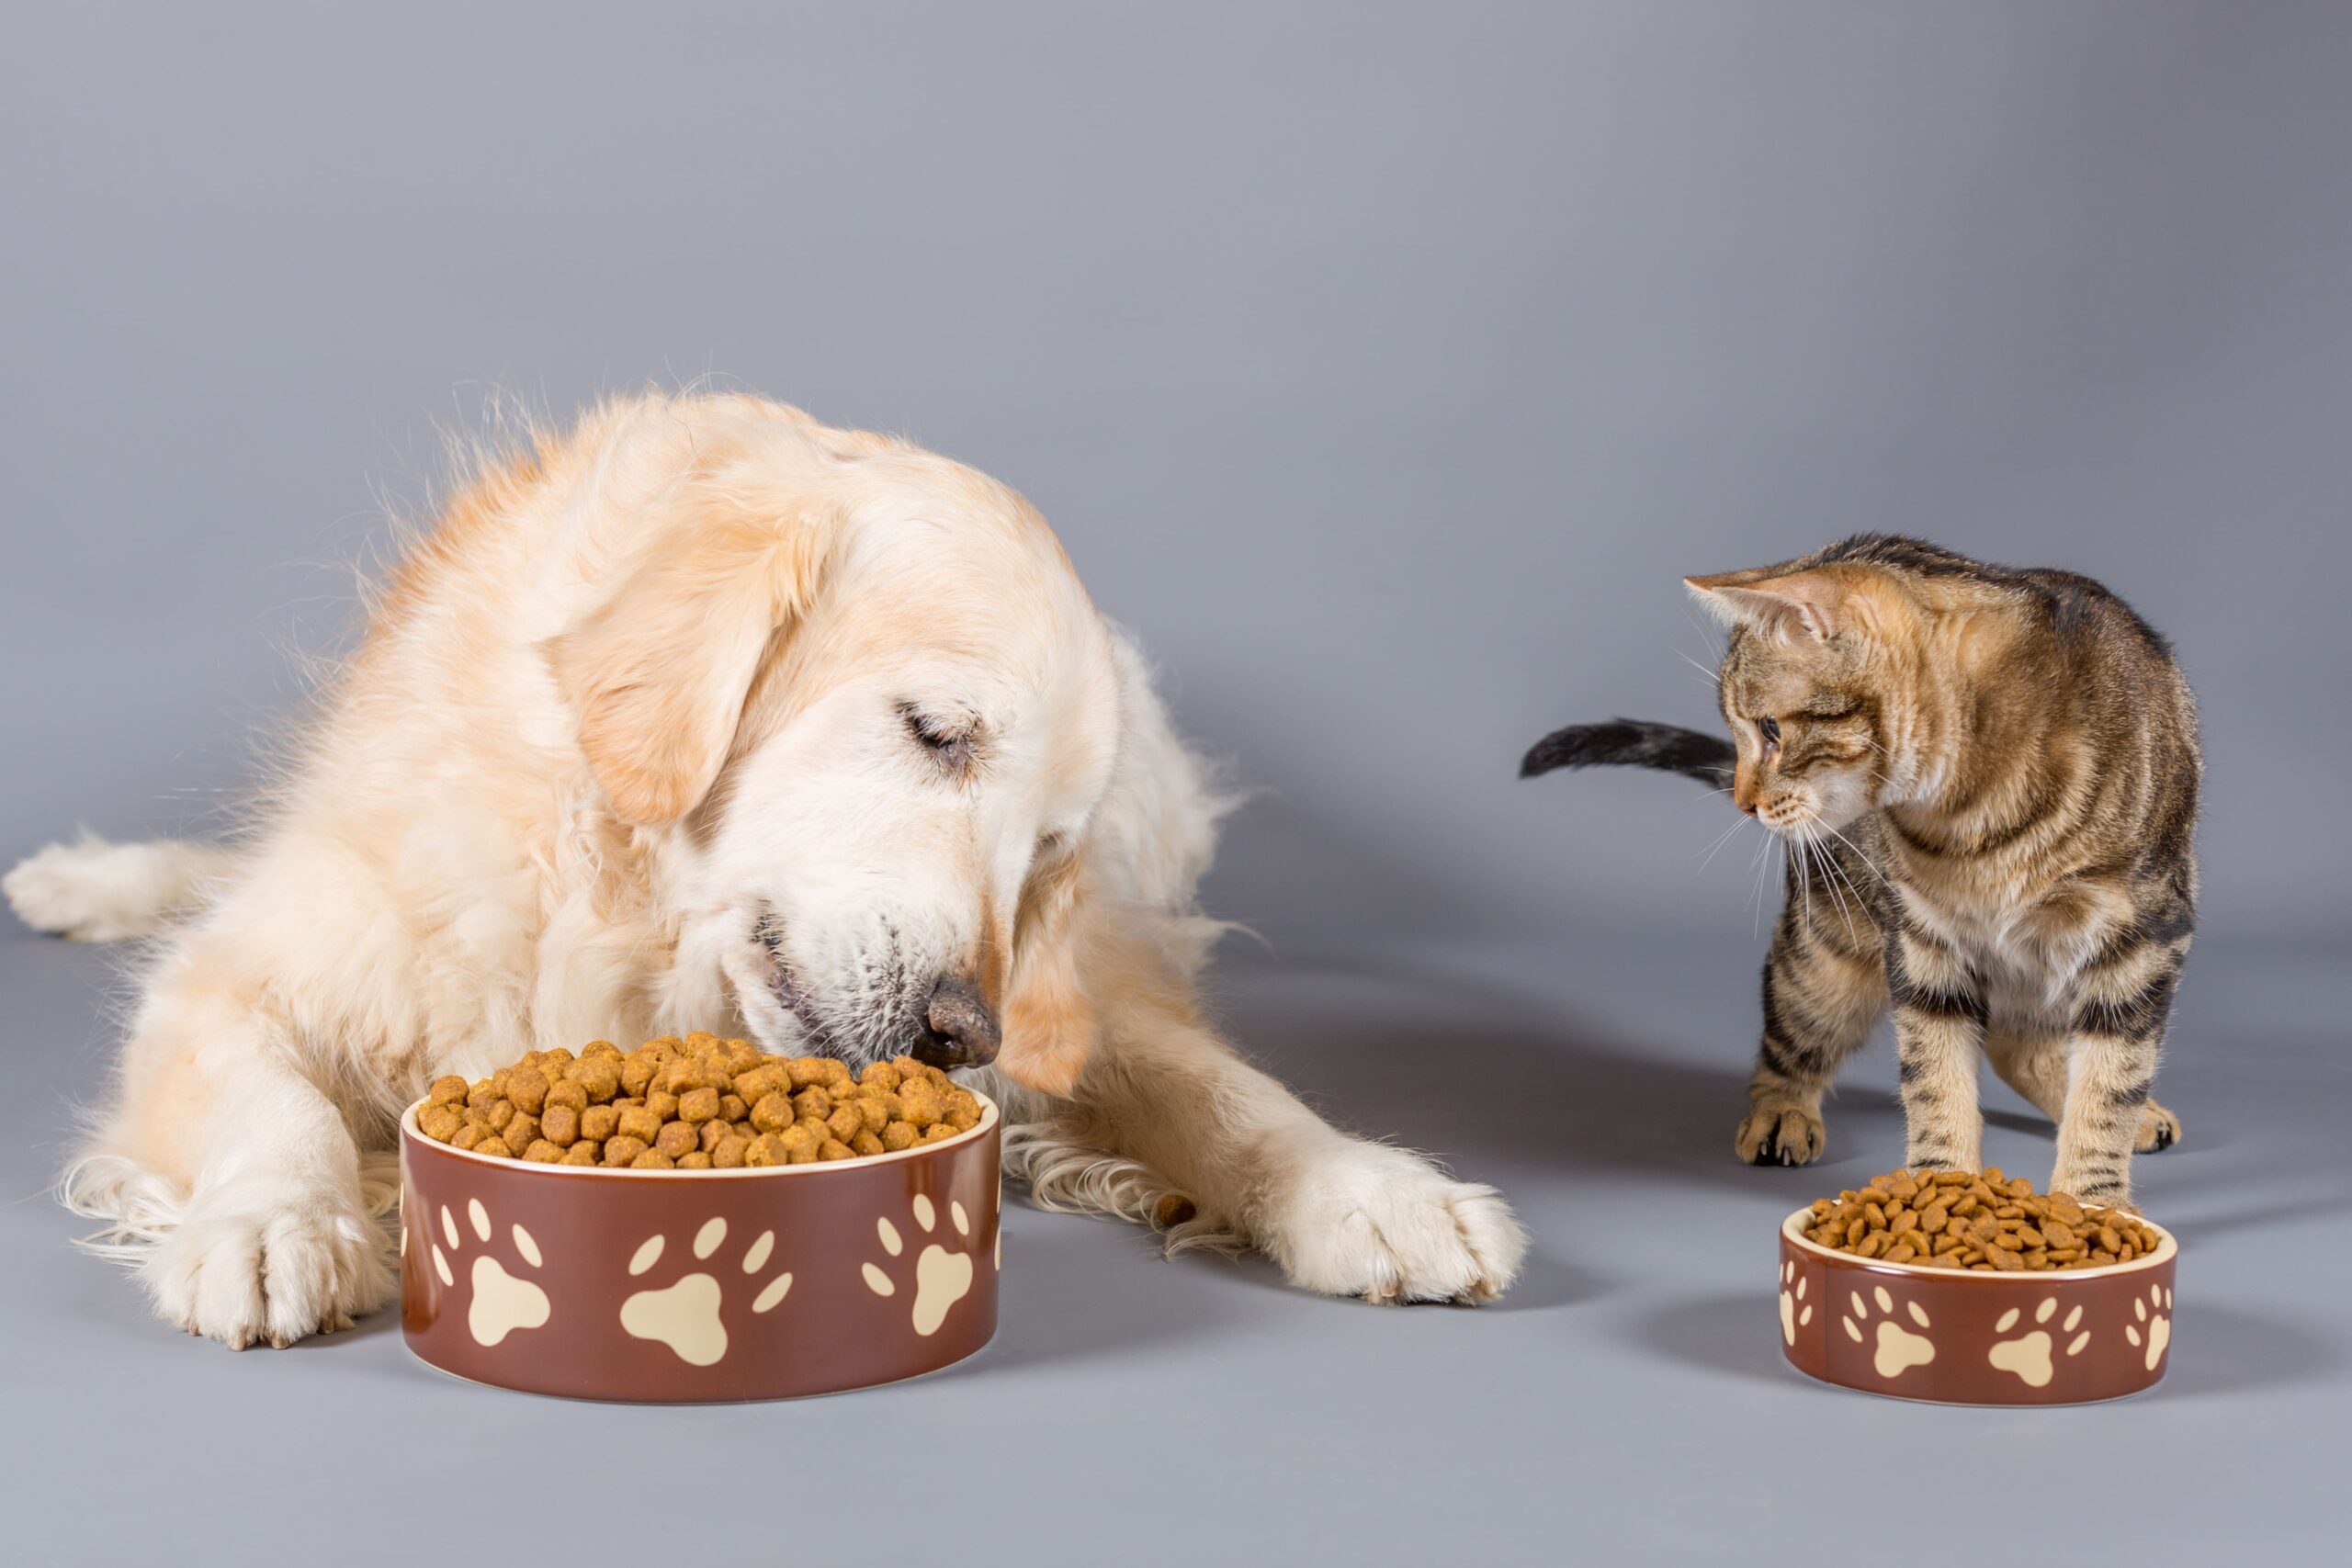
[1731,872,1886,1166]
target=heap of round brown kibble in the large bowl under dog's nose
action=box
[416,1032,981,1170]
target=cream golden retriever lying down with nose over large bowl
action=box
[5,395,1524,1347]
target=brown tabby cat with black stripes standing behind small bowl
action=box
[1520,534,2201,1203]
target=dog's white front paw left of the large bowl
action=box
[141,1199,393,1349]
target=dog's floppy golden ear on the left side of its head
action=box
[546,495,826,825]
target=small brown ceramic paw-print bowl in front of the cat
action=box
[1781,1208,2180,1405]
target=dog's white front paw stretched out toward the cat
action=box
[1261,1140,1526,1304]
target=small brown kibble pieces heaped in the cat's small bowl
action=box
[1804,1166,2159,1274]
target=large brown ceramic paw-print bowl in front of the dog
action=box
[400,1096,1002,1404]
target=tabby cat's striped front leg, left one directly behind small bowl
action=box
[1886,921,1985,1170]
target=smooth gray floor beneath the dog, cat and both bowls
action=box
[0,929,2352,1563]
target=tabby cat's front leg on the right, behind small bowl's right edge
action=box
[2051,938,2188,1203]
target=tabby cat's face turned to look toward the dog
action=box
[1687,571,1898,840]
